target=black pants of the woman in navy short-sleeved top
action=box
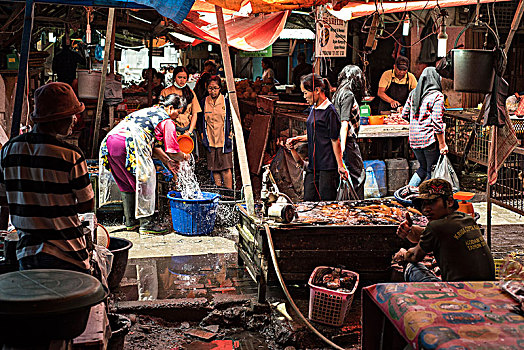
[304,169,340,202]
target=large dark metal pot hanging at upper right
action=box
[453,49,495,93]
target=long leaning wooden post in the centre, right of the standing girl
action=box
[215,5,255,215]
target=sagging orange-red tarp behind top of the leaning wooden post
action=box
[179,11,289,51]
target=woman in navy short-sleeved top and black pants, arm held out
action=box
[286,73,348,201]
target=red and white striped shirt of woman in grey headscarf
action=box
[402,90,446,149]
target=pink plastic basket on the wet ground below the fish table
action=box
[308,266,359,327]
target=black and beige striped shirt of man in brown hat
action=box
[0,133,94,270]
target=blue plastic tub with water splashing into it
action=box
[167,191,220,236]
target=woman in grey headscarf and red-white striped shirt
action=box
[402,67,448,186]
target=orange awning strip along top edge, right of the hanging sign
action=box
[328,0,511,21]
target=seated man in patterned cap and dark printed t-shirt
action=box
[393,179,495,282]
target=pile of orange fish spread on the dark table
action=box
[294,200,427,226]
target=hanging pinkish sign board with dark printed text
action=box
[315,6,348,57]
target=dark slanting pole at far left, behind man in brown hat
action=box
[11,0,35,138]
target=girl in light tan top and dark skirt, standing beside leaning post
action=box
[199,75,233,188]
